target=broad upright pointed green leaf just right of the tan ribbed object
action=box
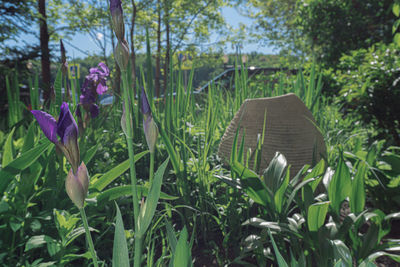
[328,153,351,216]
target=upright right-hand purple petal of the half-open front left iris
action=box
[57,102,78,145]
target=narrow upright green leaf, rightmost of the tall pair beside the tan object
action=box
[349,161,367,214]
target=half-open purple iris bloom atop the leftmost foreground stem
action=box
[31,102,80,173]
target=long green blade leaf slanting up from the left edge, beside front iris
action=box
[0,139,50,195]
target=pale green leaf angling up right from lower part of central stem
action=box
[138,158,169,236]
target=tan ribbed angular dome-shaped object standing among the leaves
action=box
[218,94,326,177]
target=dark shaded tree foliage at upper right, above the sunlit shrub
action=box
[297,0,394,66]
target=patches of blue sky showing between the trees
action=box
[4,7,277,58]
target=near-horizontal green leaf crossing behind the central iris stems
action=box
[94,185,179,202]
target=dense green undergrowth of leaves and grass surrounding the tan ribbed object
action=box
[0,55,400,266]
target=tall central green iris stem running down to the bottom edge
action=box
[121,70,142,267]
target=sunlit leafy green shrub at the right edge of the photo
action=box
[337,43,400,145]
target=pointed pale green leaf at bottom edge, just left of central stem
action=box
[112,203,129,267]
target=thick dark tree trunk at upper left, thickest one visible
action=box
[38,0,51,105]
